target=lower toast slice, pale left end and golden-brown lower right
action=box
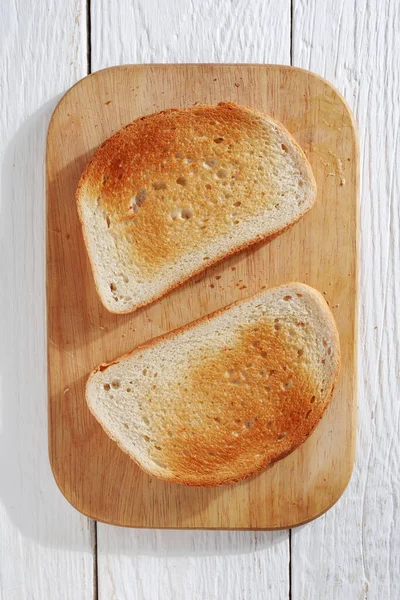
[86,283,340,486]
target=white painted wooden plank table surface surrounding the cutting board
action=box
[0,0,400,600]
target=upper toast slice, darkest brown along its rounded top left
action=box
[76,103,316,313]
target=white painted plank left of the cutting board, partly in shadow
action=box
[0,0,93,600]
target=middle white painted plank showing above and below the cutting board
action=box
[92,0,290,600]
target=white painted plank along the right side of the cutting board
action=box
[292,0,400,600]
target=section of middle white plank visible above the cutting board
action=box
[91,0,290,71]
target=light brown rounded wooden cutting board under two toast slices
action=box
[47,65,359,529]
